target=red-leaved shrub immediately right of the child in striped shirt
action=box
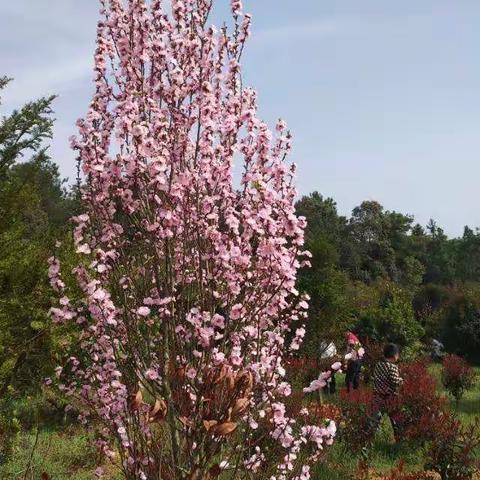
[387,361,446,441]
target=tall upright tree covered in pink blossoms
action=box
[50,0,335,480]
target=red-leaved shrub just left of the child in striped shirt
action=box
[339,389,375,452]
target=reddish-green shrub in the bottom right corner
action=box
[427,415,480,480]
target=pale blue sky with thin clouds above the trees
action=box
[0,0,480,235]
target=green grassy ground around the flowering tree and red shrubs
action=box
[0,365,480,480]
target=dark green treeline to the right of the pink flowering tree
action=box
[297,192,480,361]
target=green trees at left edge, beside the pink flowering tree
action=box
[0,77,78,402]
